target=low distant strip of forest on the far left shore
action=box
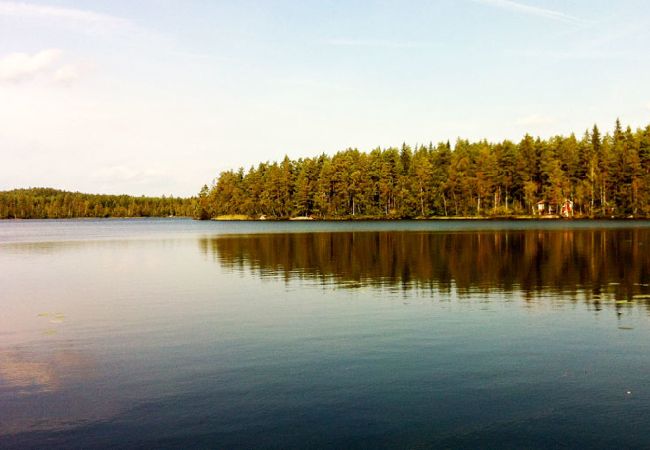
[0,188,196,219]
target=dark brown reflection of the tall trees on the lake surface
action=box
[200,228,650,311]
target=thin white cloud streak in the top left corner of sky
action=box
[0,1,129,27]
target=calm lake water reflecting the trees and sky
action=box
[0,219,650,448]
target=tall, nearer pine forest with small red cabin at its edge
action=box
[197,120,650,219]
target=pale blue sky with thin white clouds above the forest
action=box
[0,0,650,196]
